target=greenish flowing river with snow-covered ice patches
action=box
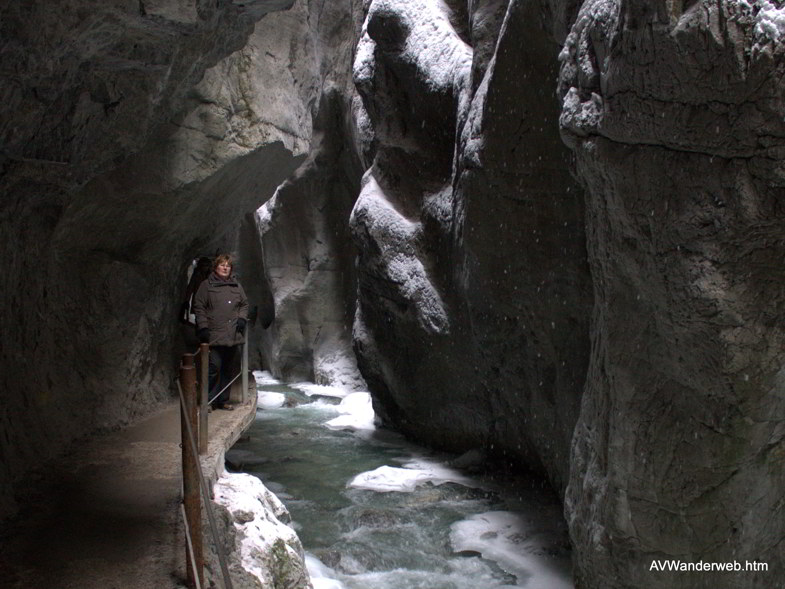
[227,373,573,589]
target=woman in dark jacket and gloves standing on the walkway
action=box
[193,254,248,411]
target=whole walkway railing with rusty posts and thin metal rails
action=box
[177,329,249,589]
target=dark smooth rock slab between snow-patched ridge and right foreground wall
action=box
[454,2,592,488]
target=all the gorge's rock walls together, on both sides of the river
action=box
[0,0,785,589]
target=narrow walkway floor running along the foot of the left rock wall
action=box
[0,395,256,589]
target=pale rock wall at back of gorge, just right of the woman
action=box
[254,88,365,390]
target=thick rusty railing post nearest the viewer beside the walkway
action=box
[180,354,204,587]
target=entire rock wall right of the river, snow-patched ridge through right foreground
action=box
[351,0,785,587]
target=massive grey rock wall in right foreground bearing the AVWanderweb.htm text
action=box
[560,0,785,588]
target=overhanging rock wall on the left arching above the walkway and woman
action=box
[0,0,311,515]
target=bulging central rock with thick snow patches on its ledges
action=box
[351,0,483,446]
